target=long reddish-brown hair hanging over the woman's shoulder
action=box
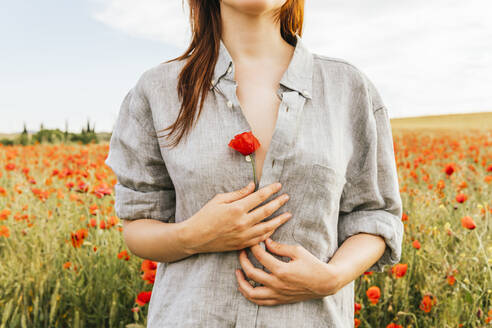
[158,0,304,147]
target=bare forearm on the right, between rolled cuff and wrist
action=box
[328,233,386,288]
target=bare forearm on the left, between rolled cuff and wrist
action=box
[123,219,193,262]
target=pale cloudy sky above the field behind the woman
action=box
[0,0,492,132]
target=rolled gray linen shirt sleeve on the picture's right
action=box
[338,73,404,272]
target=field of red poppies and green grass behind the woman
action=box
[0,130,492,328]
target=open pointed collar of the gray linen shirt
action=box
[212,34,313,99]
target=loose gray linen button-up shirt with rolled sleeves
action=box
[105,35,403,328]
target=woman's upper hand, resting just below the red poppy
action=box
[182,183,291,254]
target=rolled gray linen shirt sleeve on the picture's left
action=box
[104,78,176,222]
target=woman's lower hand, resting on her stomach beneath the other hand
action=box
[236,238,339,305]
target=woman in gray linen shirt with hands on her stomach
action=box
[106,0,403,328]
